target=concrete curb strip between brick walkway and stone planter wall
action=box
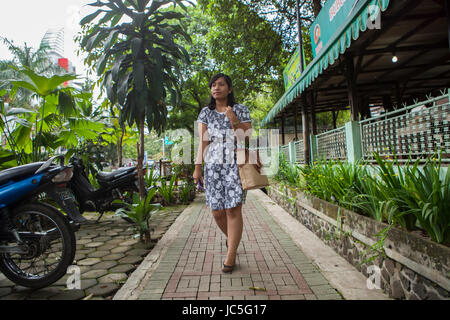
[250,190,391,300]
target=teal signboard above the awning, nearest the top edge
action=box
[309,0,359,57]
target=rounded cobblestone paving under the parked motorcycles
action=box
[0,205,186,300]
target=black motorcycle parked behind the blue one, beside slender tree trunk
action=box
[69,157,143,222]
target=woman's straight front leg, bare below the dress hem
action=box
[224,205,244,266]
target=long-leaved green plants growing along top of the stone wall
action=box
[274,154,450,244]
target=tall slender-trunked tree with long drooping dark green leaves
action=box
[80,0,190,199]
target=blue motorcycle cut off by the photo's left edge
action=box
[0,156,80,289]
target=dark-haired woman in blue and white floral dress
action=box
[193,73,251,272]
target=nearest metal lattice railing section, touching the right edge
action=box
[359,94,450,162]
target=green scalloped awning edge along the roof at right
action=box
[260,0,389,127]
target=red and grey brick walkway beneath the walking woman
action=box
[138,193,342,300]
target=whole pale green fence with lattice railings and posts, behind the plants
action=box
[279,90,450,163]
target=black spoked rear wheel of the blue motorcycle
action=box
[0,203,76,289]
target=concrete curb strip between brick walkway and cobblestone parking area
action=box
[113,195,204,300]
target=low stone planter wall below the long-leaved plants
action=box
[267,184,450,300]
